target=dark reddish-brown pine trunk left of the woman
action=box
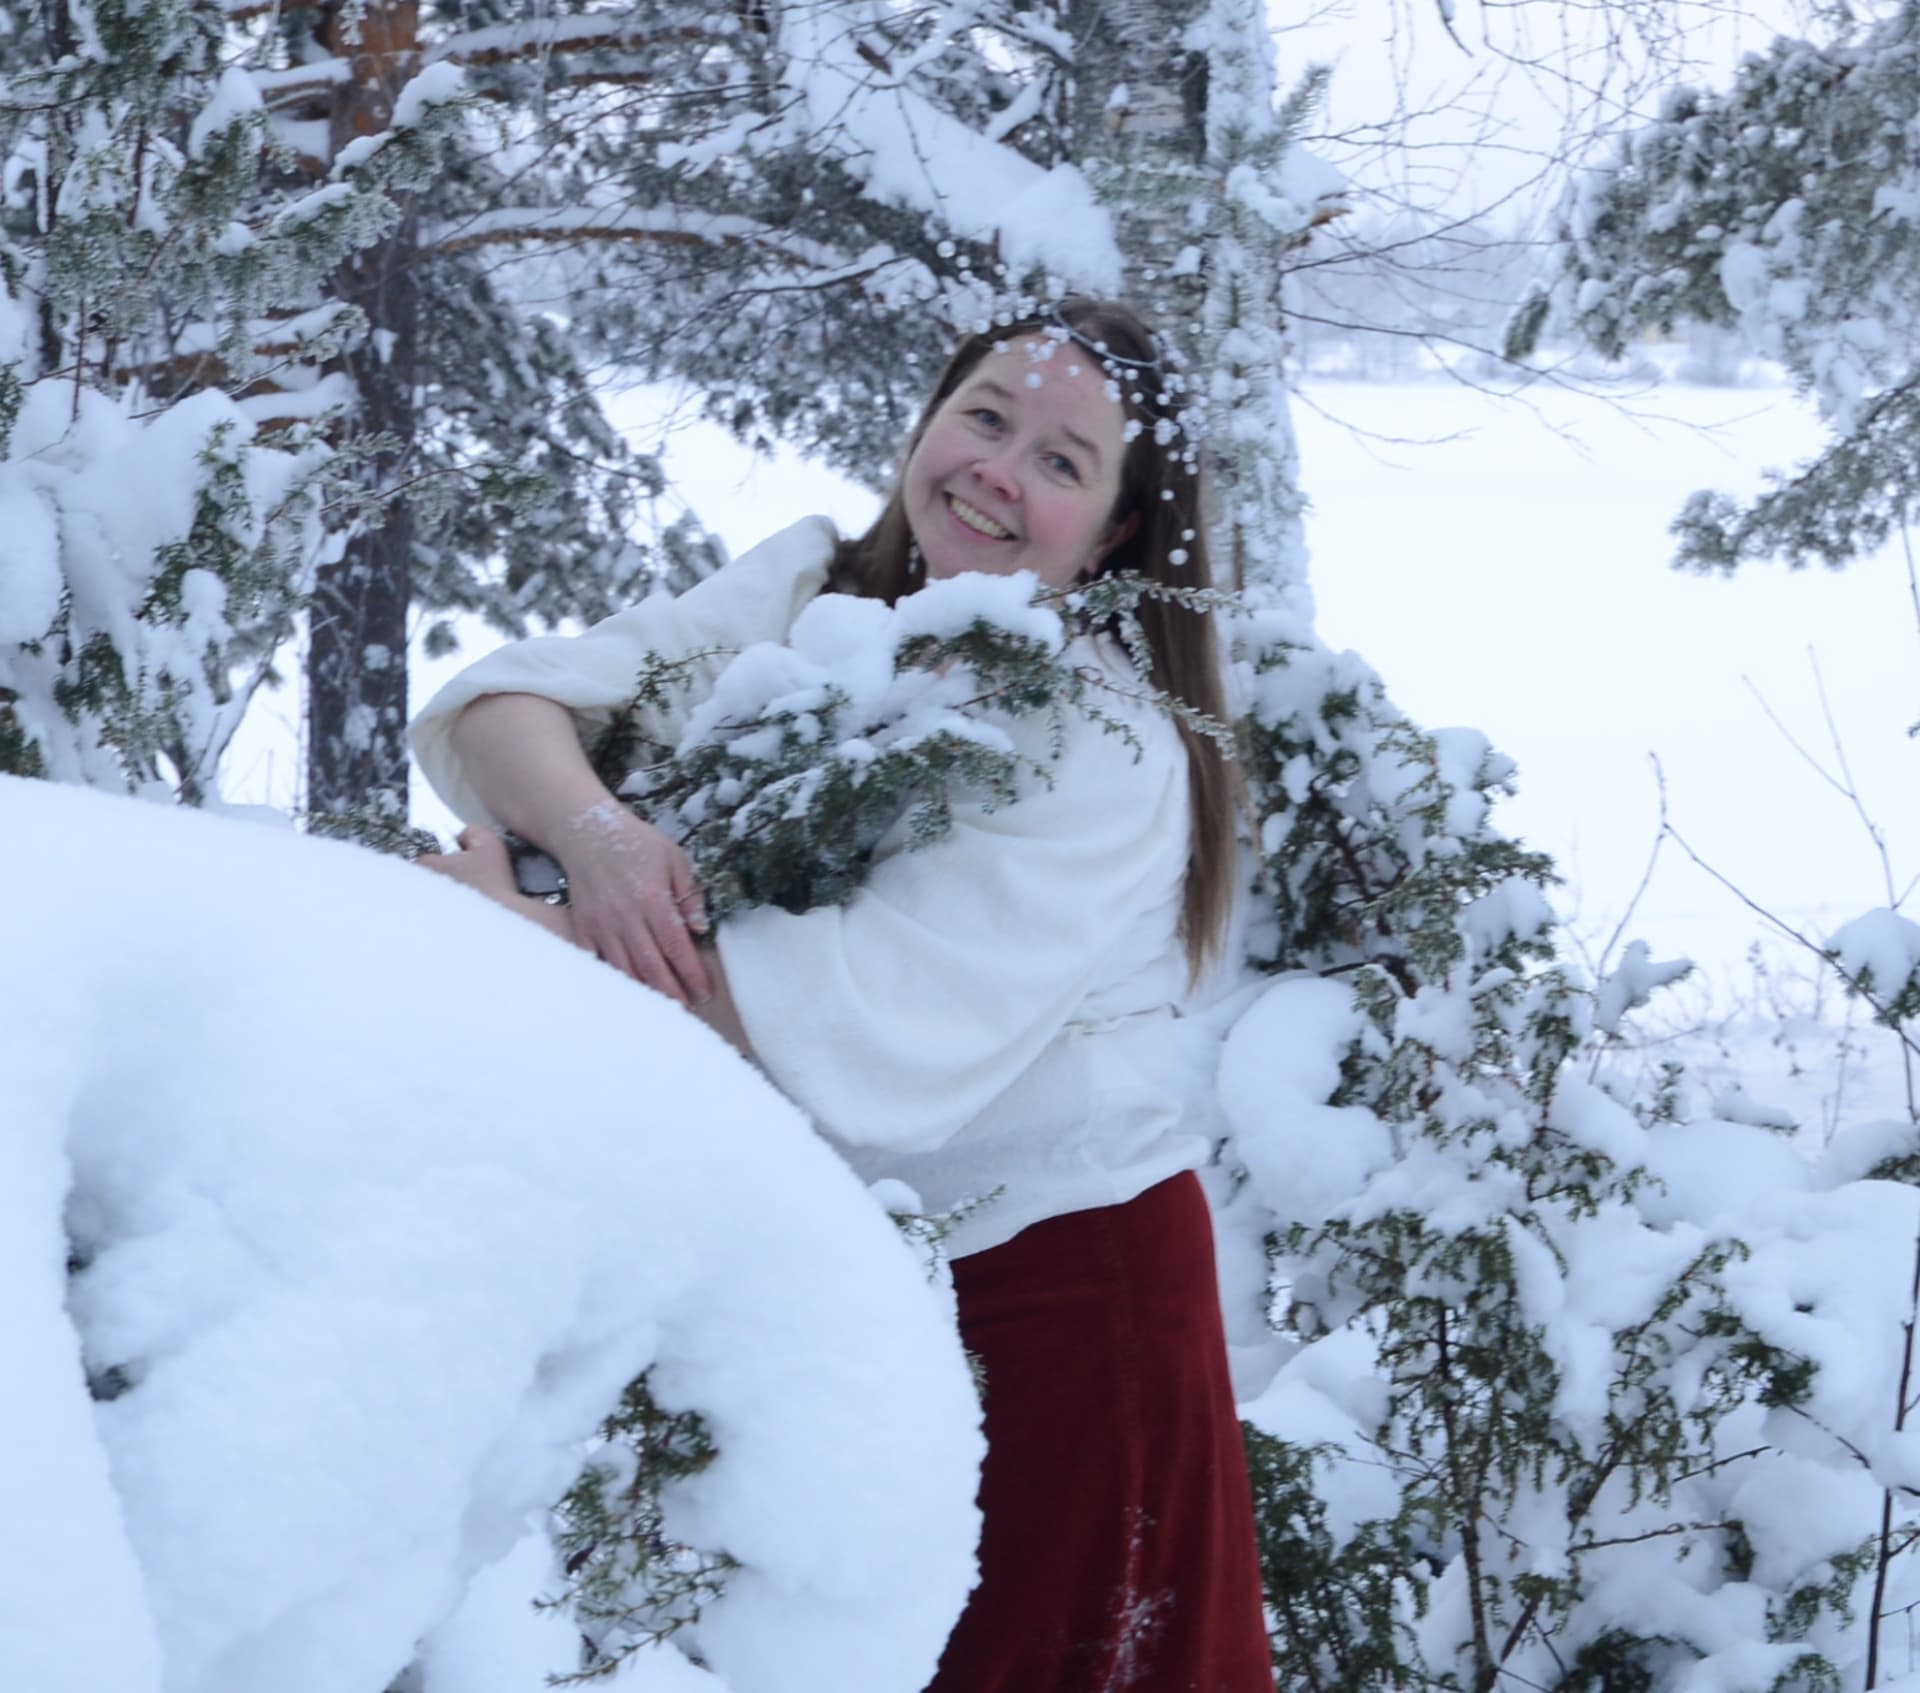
[307,0,419,818]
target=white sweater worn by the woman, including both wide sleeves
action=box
[413,518,1206,1255]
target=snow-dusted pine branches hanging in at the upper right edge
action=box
[1509,0,1920,570]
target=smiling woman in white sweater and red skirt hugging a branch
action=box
[415,299,1271,1693]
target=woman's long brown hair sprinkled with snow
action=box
[828,298,1236,977]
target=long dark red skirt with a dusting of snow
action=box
[927,1175,1273,1693]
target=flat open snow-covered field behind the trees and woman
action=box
[230,367,1920,998]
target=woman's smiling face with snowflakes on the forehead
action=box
[900,336,1131,587]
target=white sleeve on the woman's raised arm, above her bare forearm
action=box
[409,518,835,823]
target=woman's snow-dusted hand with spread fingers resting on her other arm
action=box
[551,799,712,1006]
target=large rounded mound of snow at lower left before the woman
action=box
[0,779,981,1693]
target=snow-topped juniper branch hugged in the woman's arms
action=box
[515,576,1233,919]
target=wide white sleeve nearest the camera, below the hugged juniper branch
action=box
[718,691,1188,1152]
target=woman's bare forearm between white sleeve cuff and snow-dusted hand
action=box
[451,693,614,854]
